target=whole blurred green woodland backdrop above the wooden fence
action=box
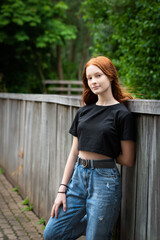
[0,0,160,99]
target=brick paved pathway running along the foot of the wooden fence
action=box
[0,174,43,240]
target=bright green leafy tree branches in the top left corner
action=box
[0,0,76,48]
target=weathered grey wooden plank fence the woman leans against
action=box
[0,94,160,240]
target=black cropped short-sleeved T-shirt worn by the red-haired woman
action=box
[69,103,136,158]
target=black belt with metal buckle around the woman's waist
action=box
[77,156,115,169]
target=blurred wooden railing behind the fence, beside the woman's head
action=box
[44,80,83,95]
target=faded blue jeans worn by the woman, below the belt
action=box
[44,159,122,240]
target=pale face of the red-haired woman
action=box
[86,65,111,95]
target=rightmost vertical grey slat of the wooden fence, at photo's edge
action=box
[147,116,160,240]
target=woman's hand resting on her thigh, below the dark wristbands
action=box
[51,193,67,218]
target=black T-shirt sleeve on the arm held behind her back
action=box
[119,112,136,141]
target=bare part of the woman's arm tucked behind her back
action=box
[117,140,135,167]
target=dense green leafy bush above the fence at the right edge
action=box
[110,0,160,99]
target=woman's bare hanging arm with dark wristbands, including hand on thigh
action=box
[51,137,78,217]
